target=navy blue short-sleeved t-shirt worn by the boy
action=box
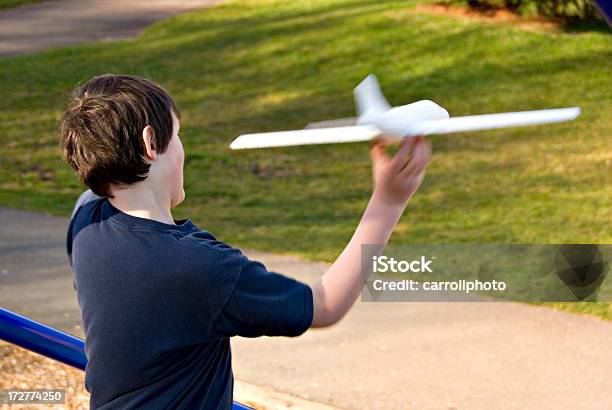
[67,193,313,409]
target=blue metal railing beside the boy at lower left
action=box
[0,307,251,410]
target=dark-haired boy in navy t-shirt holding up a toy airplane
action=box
[60,75,430,409]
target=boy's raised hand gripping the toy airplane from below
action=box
[370,137,431,207]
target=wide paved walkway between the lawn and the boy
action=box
[0,208,612,409]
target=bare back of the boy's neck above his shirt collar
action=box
[108,187,175,225]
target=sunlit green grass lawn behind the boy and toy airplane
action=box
[0,0,612,319]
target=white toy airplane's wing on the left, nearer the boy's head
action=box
[230,125,382,149]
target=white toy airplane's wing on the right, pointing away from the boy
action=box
[405,107,580,137]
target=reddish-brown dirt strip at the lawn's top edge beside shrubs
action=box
[412,4,563,33]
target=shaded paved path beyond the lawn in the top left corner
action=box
[0,0,220,56]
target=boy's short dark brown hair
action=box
[60,74,180,198]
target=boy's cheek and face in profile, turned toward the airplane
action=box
[155,113,185,208]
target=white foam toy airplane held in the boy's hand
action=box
[230,74,580,149]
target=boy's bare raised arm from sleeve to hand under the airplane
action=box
[311,137,431,327]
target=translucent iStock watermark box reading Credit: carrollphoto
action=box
[361,244,612,302]
